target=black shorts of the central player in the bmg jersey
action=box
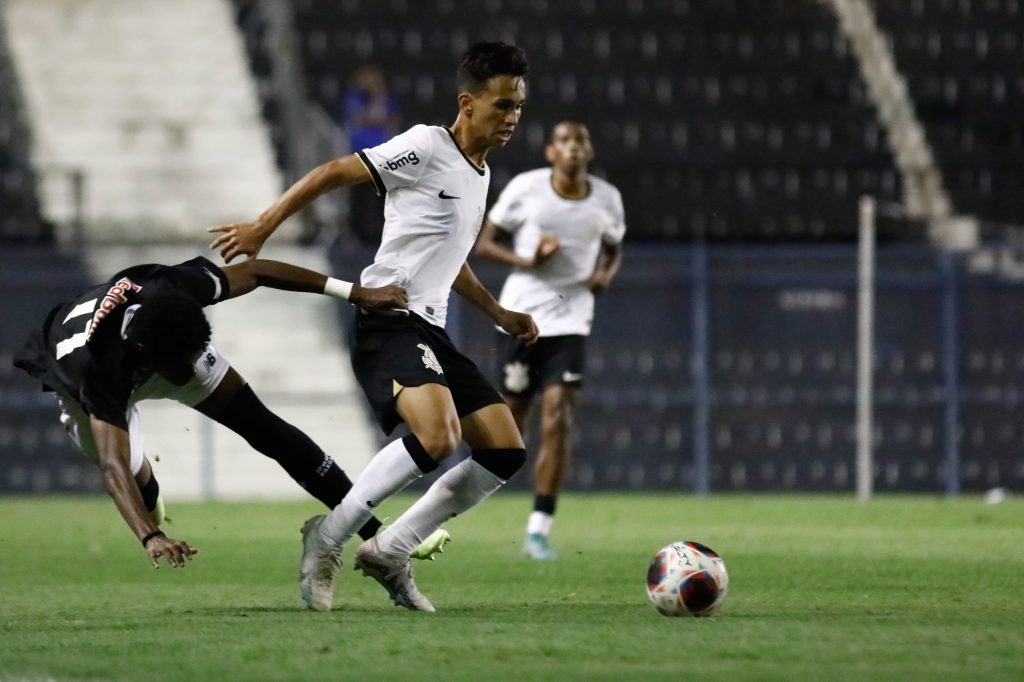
[351,312,504,433]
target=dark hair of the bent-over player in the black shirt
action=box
[128,292,211,359]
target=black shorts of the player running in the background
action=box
[498,332,587,397]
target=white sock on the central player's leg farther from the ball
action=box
[319,438,423,551]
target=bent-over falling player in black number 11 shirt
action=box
[14,251,407,566]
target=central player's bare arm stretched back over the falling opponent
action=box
[207,154,371,263]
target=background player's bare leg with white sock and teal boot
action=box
[523,384,580,560]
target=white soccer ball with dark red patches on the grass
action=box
[647,540,729,616]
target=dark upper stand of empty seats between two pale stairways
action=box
[236,0,899,242]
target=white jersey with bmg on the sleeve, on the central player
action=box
[357,125,490,327]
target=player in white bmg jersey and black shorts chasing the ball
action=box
[210,43,537,611]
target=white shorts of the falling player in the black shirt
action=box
[57,344,231,474]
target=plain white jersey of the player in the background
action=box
[488,168,626,336]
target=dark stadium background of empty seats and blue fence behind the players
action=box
[0,0,1024,493]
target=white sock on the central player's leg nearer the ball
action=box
[376,457,505,556]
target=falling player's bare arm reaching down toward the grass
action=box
[89,417,197,568]
